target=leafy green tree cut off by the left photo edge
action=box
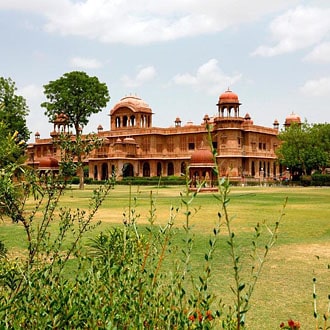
[0,77,31,144]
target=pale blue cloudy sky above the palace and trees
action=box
[0,0,330,139]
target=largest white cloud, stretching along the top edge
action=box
[0,0,298,44]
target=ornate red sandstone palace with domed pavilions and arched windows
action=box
[28,90,300,184]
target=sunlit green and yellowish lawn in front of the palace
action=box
[0,186,330,330]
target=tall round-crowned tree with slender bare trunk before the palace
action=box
[41,71,110,189]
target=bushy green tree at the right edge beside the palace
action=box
[276,122,330,175]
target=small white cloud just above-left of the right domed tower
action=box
[173,59,242,95]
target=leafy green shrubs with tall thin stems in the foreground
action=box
[0,146,283,330]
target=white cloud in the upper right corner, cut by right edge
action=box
[252,6,330,56]
